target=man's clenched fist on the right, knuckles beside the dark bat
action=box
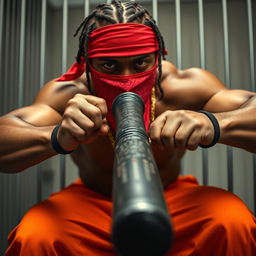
[149,110,217,150]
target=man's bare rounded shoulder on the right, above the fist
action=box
[161,61,228,110]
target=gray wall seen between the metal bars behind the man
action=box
[0,0,256,254]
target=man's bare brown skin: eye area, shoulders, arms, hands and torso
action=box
[0,53,256,196]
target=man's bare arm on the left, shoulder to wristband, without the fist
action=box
[0,81,86,173]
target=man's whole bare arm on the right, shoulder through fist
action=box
[154,63,256,152]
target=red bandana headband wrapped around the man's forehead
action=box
[88,23,159,58]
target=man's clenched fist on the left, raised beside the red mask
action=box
[57,94,109,151]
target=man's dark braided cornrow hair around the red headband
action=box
[74,0,165,97]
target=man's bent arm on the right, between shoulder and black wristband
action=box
[204,90,256,153]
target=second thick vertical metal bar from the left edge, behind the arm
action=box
[36,0,47,202]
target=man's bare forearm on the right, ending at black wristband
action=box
[214,97,256,153]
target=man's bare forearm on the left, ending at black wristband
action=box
[0,116,56,173]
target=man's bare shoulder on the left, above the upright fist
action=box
[33,74,89,114]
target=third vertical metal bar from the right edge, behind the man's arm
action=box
[198,0,209,185]
